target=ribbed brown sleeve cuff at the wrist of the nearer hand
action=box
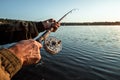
[0,48,22,77]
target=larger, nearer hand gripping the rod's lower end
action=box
[9,39,42,65]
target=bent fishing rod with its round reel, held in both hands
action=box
[37,9,76,54]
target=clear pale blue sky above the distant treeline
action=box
[0,0,120,22]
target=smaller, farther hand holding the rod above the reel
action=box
[42,19,60,32]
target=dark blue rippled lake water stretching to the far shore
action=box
[10,26,120,80]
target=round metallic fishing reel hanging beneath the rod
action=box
[44,36,62,54]
